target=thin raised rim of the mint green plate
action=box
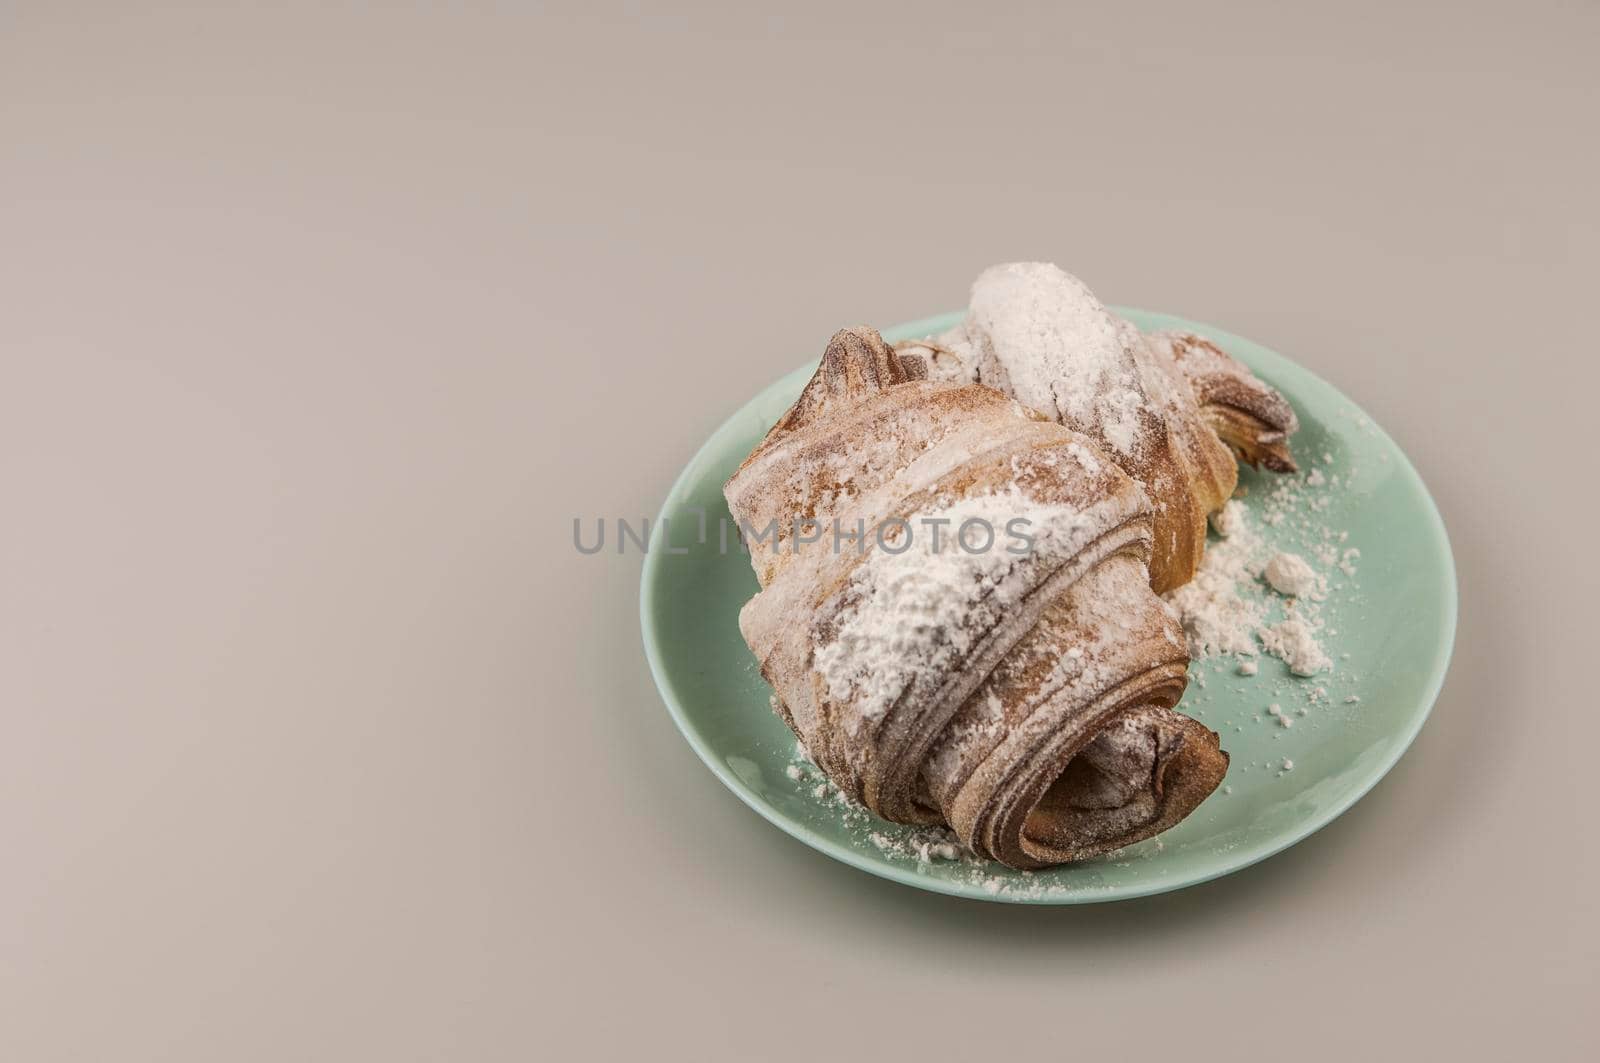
[638,306,1459,906]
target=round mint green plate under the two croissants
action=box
[640,309,1456,905]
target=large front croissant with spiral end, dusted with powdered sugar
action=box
[725,328,1227,868]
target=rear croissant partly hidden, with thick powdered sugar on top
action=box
[899,263,1296,592]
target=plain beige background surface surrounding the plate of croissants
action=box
[0,2,1600,1063]
